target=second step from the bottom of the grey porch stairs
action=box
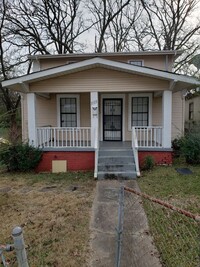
[98,163,135,172]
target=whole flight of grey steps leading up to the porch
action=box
[98,147,136,179]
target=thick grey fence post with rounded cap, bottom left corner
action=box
[12,227,29,267]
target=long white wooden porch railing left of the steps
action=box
[36,127,91,148]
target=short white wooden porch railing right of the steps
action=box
[133,126,162,148]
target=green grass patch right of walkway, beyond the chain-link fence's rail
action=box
[138,164,200,213]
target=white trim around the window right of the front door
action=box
[128,93,152,131]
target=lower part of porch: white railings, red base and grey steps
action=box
[36,127,172,179]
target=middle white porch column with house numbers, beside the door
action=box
[90,92,99,147]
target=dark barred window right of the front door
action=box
[131,97,149,126]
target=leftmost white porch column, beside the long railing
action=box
[27,93,36,146]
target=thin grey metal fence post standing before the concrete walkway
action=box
[115,186,124,267]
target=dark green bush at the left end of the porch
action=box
[0,143,42,171]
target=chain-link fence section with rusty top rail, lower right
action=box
[116,187,200,267]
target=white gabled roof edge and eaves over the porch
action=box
[2,57,200,92]
